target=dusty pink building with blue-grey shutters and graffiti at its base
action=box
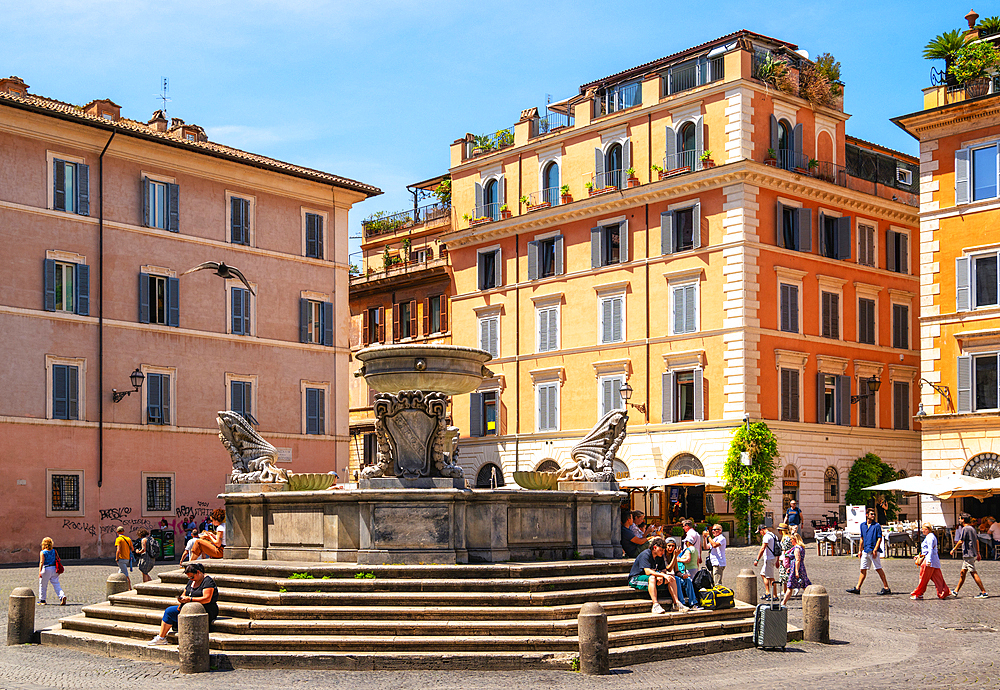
[0,77,380,562]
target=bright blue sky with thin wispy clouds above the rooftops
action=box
[0,0,968,260]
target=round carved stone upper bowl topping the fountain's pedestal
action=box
[354,344,493,395]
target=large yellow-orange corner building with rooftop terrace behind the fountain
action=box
[441,31,919,519]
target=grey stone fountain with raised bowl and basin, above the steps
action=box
[222,344,624,565]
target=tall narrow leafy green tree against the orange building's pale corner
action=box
[722,422,778,534]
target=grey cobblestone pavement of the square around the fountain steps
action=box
[0,548,1000,690]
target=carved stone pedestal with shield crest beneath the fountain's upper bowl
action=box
[361,391,463,479]
